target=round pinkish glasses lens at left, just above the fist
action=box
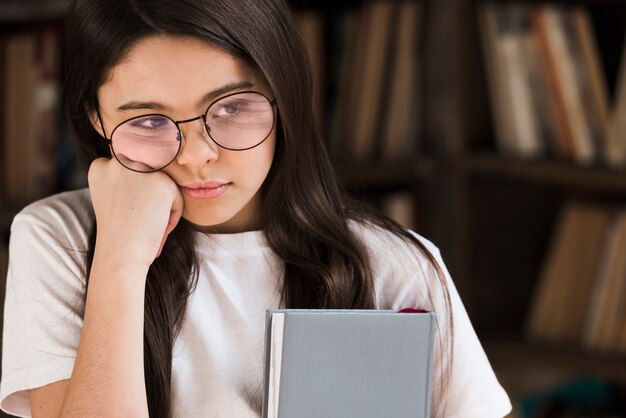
[111,115,180,172]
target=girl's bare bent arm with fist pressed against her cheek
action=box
[30,160,182,417]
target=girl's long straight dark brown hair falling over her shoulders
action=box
[64,0,452,417]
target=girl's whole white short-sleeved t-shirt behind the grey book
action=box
[0,189,511,418]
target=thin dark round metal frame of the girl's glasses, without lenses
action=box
[96,90,276,173]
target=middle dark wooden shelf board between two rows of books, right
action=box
[465,155,626,195]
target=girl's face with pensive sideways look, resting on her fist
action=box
[94,36,276,233]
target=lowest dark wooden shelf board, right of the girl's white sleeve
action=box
[484,340,626,399]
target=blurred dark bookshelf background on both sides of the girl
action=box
[0,0,626,418]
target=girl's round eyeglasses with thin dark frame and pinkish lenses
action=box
[98,91,276,173]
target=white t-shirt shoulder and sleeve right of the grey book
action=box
[360,225,511,418]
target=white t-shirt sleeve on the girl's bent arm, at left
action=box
[0,197,86,416]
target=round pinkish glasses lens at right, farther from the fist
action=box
[206,93,274,150]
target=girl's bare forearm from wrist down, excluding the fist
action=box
[61,258,148,417]
